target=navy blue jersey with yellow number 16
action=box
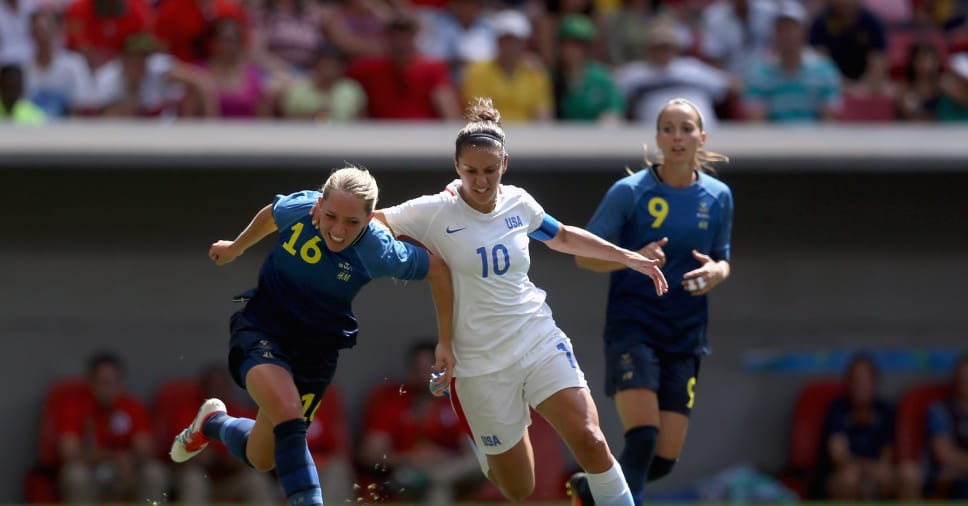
[245,191,430,351]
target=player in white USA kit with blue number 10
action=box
[358,99,668,506]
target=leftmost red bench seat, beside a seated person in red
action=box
[24,378,87,504]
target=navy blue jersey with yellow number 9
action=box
[587,168,733,353]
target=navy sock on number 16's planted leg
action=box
[272,418,323,506]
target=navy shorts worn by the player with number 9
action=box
[605,340,701,416]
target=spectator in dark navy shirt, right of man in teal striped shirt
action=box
[809,0,890,93]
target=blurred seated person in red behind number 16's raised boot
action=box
[164,364,275,504]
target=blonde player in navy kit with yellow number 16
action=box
[171,167,453,506]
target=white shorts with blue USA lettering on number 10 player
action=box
[451,330,588,455]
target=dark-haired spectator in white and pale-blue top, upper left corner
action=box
[24,9,97,118]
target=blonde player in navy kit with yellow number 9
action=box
[570,99,733,506]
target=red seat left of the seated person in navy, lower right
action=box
[780,380,845,498]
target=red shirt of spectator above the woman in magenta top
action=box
[155,0,248,63]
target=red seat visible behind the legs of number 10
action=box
[473,410,575,502]
